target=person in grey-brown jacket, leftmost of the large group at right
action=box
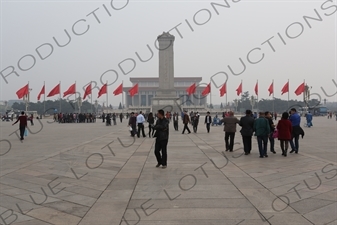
[222,111,240,152]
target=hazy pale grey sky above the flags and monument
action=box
[0,0,337,105]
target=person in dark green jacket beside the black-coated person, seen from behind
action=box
[254,112,270,158]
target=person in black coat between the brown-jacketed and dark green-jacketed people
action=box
[239,110,255,155]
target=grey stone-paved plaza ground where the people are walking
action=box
[0,117,337,225]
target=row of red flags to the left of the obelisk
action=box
[16,83,138,100]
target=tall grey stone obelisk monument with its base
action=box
[152,32,180,113]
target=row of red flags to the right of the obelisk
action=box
[186,81,305,97]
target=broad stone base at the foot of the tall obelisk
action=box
[152,96,182,115]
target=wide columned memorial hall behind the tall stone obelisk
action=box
[123,77,207,108]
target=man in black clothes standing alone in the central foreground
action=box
[153,109,169,169]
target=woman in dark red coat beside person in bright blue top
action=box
[277,112,292,157]
